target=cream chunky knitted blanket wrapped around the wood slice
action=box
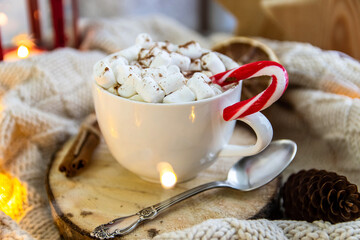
[0,16,360,240]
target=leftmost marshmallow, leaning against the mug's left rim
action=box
[93,60,116,89]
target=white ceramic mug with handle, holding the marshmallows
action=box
[93,82,273,182]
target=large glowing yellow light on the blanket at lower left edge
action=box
[0,173,27,220]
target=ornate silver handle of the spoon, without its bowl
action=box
[90,181,231,239]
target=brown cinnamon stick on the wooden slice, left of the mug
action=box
[59,114,100,177]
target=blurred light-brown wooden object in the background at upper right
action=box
[217,0,360,59]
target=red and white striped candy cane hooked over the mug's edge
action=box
[210,61,289,121]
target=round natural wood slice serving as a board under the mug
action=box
[47,124,280,239]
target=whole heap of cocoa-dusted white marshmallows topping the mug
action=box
[94,33,239,103]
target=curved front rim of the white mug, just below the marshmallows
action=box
[92,81,242,106]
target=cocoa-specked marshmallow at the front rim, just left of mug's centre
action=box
[135,77,165,103]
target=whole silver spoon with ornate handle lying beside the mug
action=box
[90,139,297,239]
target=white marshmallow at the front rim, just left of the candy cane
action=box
[187,73,215,100]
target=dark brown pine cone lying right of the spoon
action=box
[281,169,360,223]
